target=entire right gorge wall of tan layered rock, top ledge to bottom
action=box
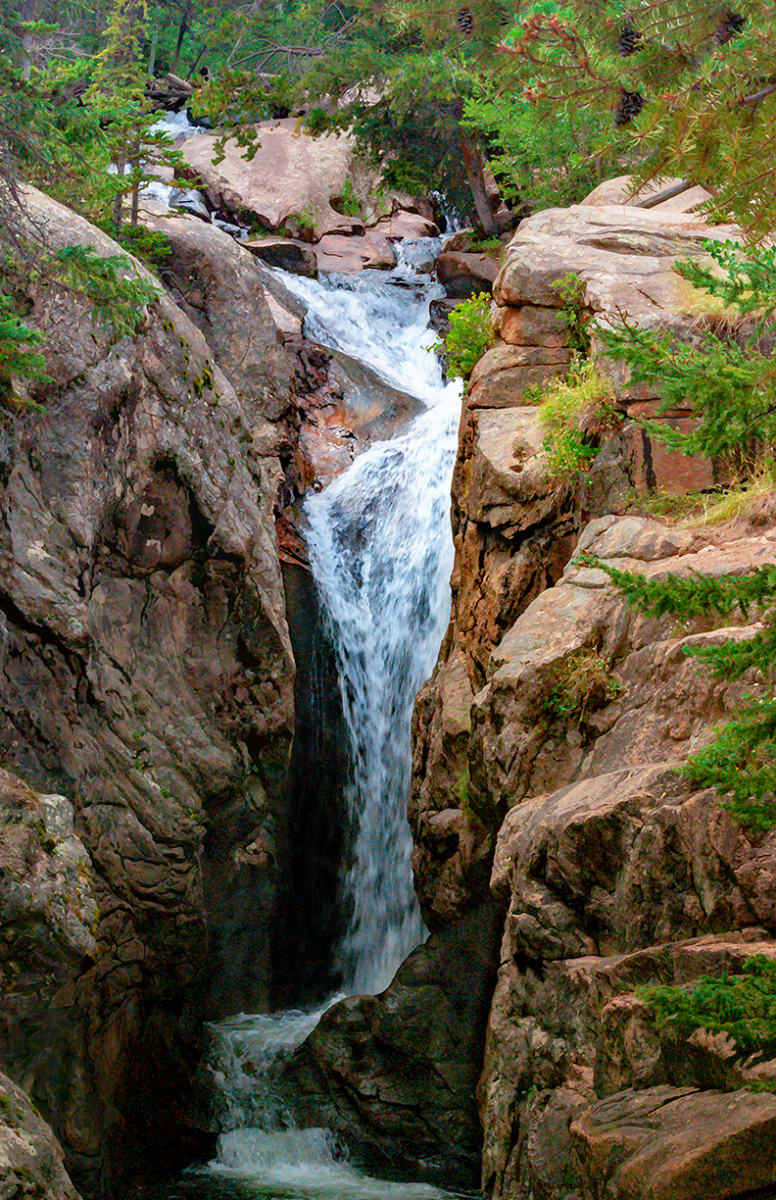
[410,184,776,1200]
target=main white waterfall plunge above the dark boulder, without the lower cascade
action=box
[289,246,461,992]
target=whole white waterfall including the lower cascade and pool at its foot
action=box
[168,241,461,1200]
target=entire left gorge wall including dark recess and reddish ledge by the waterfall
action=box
[0,131,455,1196]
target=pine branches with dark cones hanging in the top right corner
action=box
[500,0,776,235]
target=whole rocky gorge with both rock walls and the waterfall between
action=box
[0,159,776,1200]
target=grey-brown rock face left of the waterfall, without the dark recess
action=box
[0,192,294,1194]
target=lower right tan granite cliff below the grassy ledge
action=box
[470,517,776,1200]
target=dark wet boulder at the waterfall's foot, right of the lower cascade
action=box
[288,905,499,1187]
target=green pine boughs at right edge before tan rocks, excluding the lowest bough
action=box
[582,242,776,830]
